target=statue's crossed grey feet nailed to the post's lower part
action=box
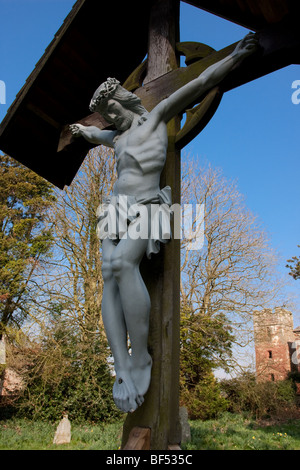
[113,353,152,413]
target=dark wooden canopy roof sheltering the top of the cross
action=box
[0,0,298,188]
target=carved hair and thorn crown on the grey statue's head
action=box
[90,78,147,115]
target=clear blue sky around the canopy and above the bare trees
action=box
[0,0,300,326]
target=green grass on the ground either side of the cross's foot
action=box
[0,413,300,450]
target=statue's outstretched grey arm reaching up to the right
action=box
[156,33,258,123]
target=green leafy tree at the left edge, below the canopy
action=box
[0,155,54,335]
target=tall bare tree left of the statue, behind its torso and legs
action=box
[36,147,115,342]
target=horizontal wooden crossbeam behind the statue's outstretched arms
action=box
[58,16,300,173]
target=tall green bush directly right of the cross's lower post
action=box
[180,308,234,419]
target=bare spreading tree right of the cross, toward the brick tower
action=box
[181,159,290,370]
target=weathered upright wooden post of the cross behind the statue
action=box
[122,0,181,450]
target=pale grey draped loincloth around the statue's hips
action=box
[96,186,172,258]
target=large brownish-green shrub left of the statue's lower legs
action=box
[0,318,120,423]
